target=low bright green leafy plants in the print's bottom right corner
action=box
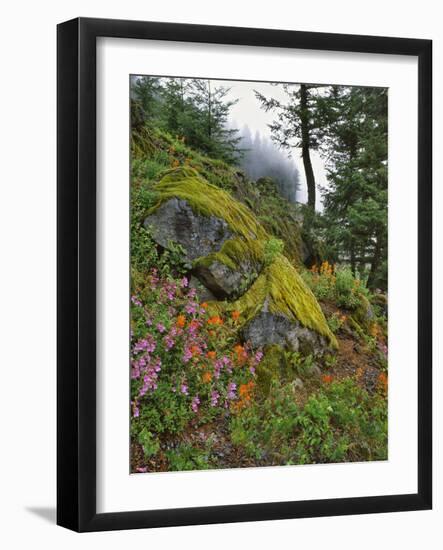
[230,379,387,464]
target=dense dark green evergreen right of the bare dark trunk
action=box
[321,86,388,288]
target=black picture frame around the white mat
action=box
[57,18,432,532]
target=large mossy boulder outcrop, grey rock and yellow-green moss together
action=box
[145,168,337,355]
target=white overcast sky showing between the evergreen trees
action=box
[216,80,327,209]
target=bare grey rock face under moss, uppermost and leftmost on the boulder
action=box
[144,197,236,264]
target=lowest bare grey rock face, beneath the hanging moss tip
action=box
[243,310,327,355]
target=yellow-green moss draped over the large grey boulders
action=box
[153,167,337,347]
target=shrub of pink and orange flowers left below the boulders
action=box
[131,269,263,464]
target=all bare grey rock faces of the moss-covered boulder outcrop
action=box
[144,198,328,362]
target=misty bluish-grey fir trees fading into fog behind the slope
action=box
[238,126,300,202]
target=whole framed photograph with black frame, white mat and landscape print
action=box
[57,18,432,531]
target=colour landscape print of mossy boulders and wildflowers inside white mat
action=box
[129,75,388,474]
